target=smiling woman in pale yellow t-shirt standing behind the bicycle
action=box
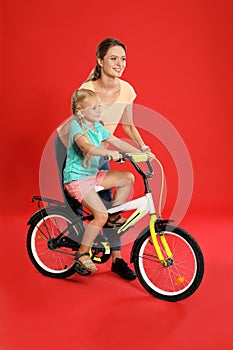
[58,38,153,280]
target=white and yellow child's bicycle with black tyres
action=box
[27,153,204,302]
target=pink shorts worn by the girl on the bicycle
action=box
[64,170,108,202]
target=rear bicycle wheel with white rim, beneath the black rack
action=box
[27,207,84,278]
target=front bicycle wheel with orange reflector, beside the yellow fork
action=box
[132,226,204,301]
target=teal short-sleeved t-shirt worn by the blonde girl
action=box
[64,120,110,184]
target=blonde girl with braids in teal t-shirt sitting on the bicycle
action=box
[64,89,145,272]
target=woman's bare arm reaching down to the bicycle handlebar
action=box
[122,104,150,151]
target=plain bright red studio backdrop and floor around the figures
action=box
[0,0,233,350]
